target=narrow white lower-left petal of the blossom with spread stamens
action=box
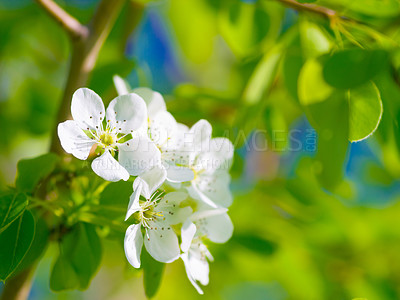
[124,224,143,268]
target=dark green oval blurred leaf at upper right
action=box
[323,49,388,89]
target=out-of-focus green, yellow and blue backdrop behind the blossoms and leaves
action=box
[0,0,400,300]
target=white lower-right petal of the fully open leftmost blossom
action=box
[118,134,161,176]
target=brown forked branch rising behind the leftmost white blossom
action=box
[0,0,133,300]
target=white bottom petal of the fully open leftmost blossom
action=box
[92,151,129,181]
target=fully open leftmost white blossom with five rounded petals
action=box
[58,88,157,181]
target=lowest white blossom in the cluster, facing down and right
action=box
[181,208,233,294]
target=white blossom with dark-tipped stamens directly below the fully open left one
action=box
[124,166,192,268]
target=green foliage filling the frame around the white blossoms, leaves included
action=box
[0,0,400,300]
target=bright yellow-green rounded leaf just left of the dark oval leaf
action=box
[298,59,333,105]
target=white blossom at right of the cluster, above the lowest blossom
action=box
[169,120,234,207]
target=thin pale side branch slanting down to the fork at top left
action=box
[35,0,89,39]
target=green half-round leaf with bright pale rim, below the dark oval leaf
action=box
[348,82,383,142]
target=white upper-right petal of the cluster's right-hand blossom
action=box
[196,138,234,173]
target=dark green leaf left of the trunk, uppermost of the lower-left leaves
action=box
[15,153,59,192]
